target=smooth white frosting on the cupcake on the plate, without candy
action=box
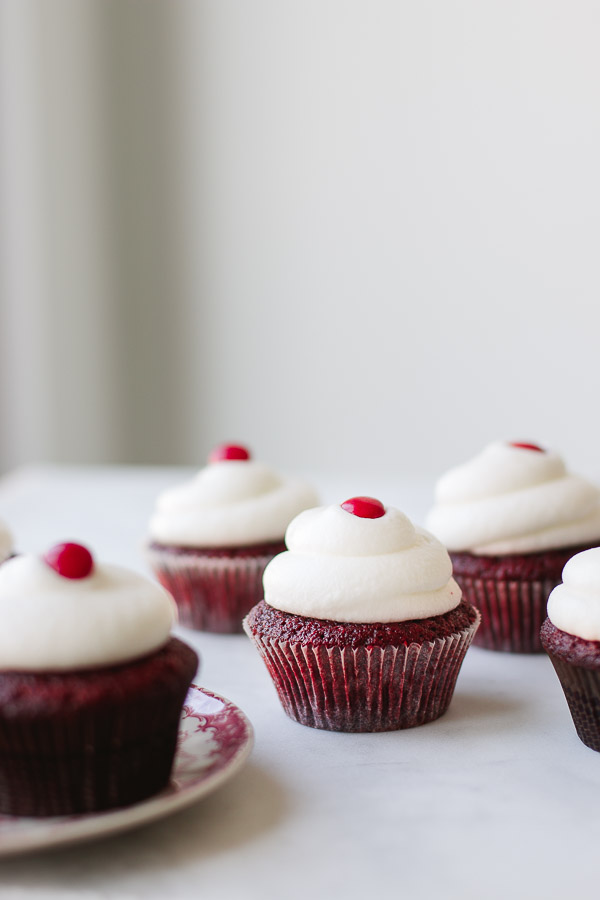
[0,554,176,672]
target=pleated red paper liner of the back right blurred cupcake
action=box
[455,574,560,653]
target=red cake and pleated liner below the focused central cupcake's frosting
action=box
[244,601,479,732]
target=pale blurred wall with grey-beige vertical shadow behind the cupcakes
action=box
[0,0,600,492]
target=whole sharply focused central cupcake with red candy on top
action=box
[244,497,479,732]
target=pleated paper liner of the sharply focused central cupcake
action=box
[244,616,479,732]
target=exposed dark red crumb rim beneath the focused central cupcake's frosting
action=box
[248,600,477,648]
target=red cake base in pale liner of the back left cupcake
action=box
[147,541,286,634]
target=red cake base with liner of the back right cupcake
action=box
[450,546,589,653]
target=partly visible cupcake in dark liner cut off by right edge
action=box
[541,547,600,751]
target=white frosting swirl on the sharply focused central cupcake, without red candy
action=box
[263,506,461,622]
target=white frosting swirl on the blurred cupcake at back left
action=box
[150,460,318,547]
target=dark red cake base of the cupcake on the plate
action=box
[0,638,198,816]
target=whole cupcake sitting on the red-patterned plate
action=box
[0,544,198,816]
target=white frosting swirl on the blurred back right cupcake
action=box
[426,441,600,556]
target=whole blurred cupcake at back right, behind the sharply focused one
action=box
[426,442,600,653]
